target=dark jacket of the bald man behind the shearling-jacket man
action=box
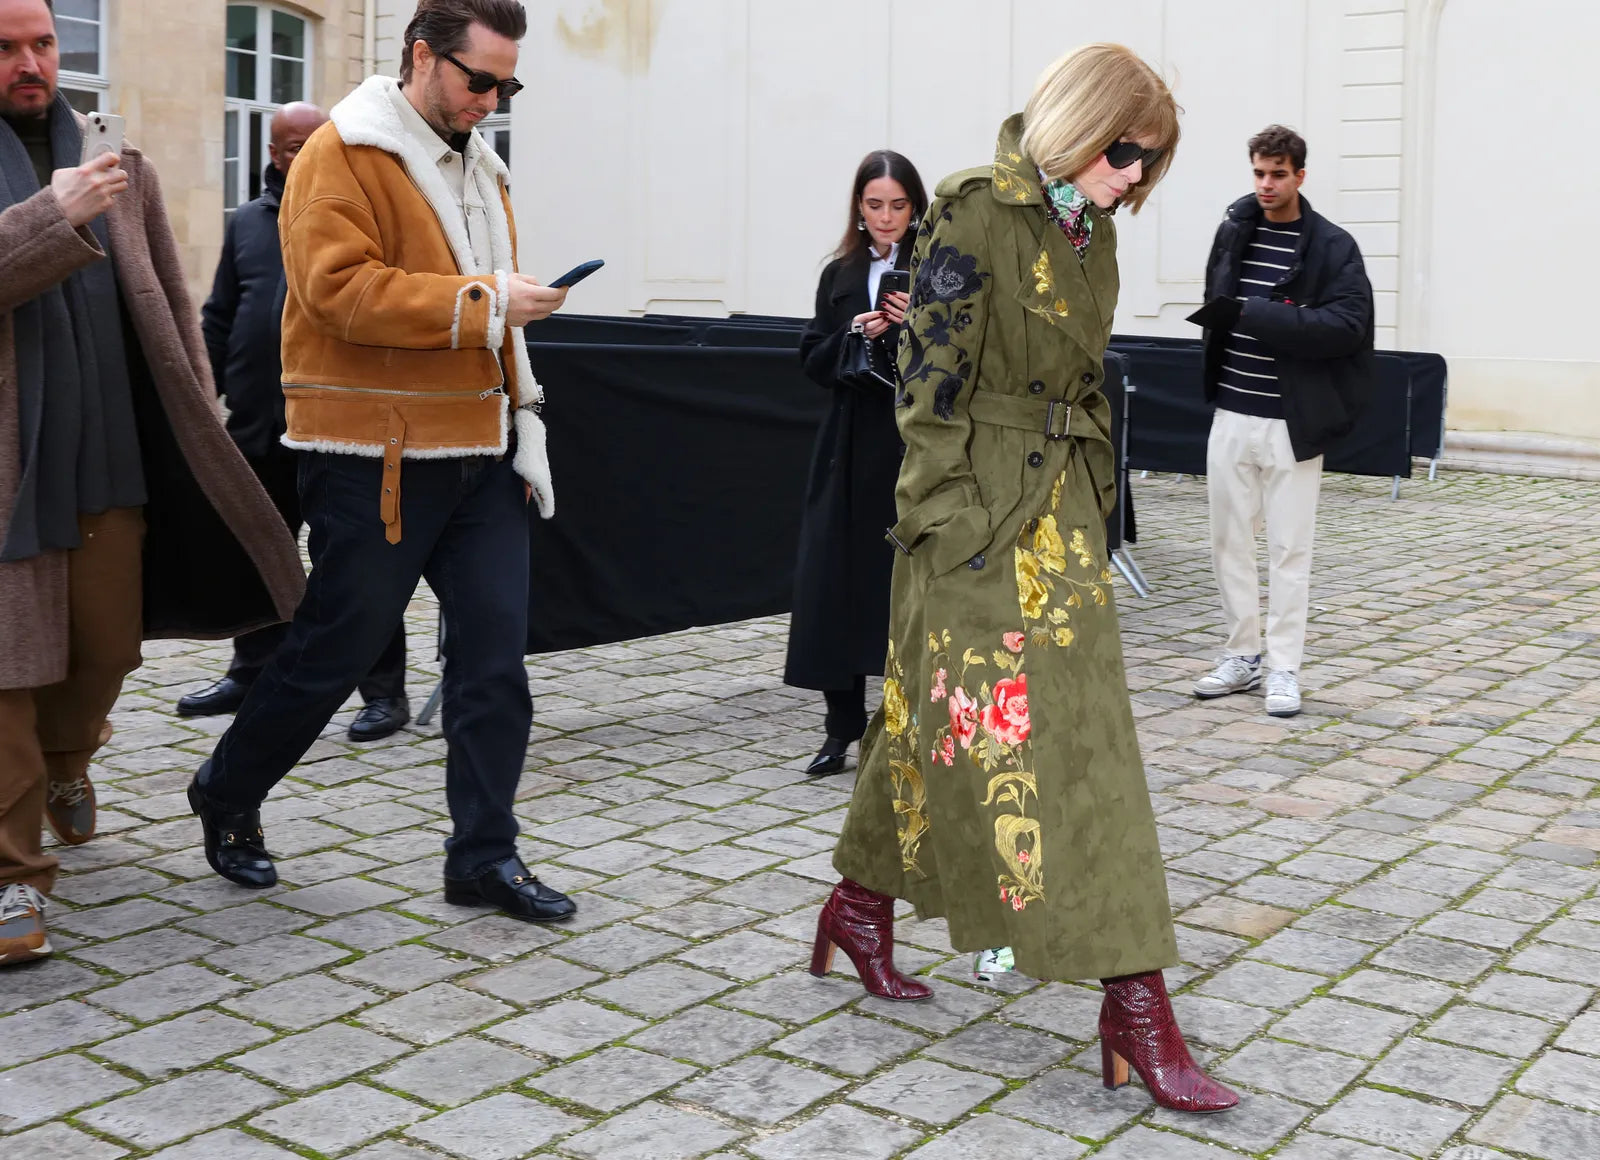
[200,165,286,459]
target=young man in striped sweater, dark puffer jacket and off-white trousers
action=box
[1194,125,1373,717]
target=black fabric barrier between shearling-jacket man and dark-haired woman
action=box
[528,339,825,653]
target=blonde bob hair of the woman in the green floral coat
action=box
[1022,45,1181,213]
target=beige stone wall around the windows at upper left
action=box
[85,0,378,302]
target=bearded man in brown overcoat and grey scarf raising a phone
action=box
[0,0,304,968]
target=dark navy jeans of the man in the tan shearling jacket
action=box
[200,451,533,878]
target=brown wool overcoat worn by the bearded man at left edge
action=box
[0,147,306,688]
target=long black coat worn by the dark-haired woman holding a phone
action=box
[784,238,912,690]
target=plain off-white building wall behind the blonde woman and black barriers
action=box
[502,0,1600,450]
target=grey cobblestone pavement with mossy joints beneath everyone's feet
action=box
[0,475,1600,1160]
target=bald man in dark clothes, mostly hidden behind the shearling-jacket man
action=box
[178,102,411,741]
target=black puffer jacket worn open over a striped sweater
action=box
[1205,195,1376,459]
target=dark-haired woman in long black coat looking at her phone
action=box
[784,149,928,776]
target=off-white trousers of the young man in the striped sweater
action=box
[1206,408,1322,672]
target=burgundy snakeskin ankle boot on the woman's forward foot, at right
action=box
[1101,971,1238,1112]
